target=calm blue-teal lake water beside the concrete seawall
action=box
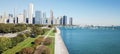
[60,27,120,54]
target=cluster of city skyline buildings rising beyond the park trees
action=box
[0,3,73,25]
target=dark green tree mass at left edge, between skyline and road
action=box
[0,24,27,33]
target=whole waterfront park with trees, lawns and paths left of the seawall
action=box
[0,23,56,54]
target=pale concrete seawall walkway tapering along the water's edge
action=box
[54,27,69,54]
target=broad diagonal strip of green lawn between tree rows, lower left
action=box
[3,36,40,54]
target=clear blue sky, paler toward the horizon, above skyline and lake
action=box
[0,0,120,25]
